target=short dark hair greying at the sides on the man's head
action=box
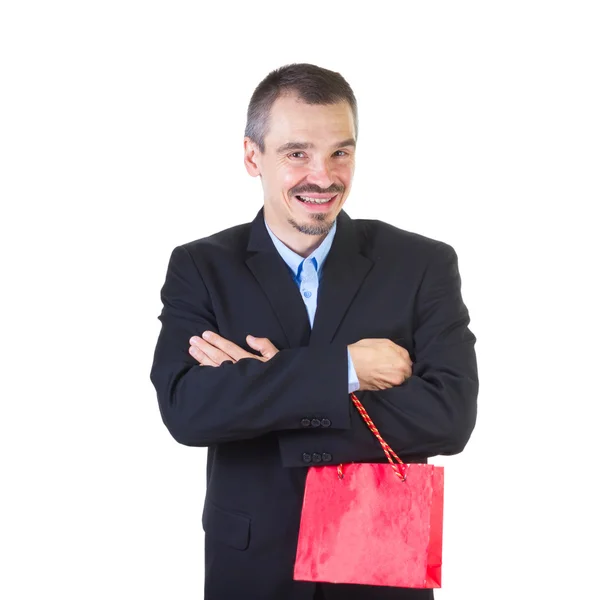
[244,63,359,152]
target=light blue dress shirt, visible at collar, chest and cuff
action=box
[265,221,359,393]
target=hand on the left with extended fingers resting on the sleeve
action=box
[189,331,279,367]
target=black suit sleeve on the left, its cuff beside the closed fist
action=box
[150,246,352,446]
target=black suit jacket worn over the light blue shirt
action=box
[150,208,478,600]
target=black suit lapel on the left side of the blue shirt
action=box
[246,208,310,348]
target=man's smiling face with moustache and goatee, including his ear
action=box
[245,95,355,236]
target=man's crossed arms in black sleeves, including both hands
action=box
[150,244,478,466]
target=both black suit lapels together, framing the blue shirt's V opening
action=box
[246,208,373,348]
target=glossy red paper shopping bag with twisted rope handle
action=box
[294,394,443,588]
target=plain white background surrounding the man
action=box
[0,0,591,600]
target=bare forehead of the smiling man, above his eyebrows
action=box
[267,95,355,144]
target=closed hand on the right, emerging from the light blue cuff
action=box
[348,338,412,391]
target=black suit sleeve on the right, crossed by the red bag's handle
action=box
[280,242,478,466]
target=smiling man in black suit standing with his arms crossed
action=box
[151,64,478,600]
